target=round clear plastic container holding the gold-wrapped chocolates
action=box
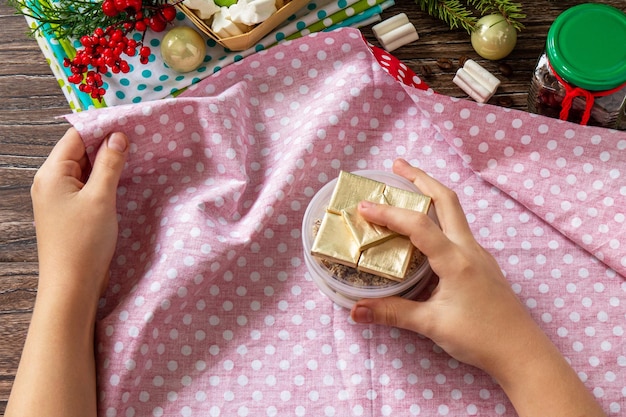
[302,170,437,308]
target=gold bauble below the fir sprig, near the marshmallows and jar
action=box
[472,14,517,60]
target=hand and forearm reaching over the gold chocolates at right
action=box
[351,160,604,417]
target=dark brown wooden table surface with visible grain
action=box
[0,0,626,415]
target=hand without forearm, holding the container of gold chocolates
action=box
[352,160,536,369]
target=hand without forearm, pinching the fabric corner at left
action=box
[31,128,128,301]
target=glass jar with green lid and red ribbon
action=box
[528,3,626,130]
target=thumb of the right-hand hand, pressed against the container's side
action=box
[350,297,428,333]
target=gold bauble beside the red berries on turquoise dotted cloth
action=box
[161,26,206,72]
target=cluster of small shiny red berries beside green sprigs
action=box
[63,0,176,100]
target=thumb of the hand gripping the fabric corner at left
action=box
[87,132,128,194]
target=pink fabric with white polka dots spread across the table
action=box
[68,29,626,417]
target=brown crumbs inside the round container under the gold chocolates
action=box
[313,219,426,288]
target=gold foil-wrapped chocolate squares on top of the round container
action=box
[311,171,431,281]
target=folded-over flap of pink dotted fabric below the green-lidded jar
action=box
[422,99,626,275]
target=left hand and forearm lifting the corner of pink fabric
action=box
[5,129,128,417]
